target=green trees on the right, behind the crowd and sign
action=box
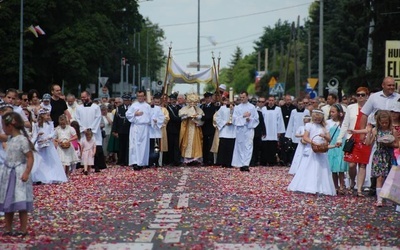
[224,0,400,95]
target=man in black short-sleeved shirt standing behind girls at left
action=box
[50,84,71,127]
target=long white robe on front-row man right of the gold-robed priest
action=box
[232,102,259,167]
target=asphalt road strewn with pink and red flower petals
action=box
[0,167,400,249]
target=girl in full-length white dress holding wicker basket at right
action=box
[288,109,336,195]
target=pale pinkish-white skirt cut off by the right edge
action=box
[379,166,400,204]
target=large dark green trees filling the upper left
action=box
[0,0,164,93]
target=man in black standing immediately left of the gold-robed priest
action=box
[163,93,181,166]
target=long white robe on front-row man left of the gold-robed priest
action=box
[125,99,152,167]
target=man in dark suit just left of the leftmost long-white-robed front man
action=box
[111,94,132,166]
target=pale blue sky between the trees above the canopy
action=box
[139,0,313,93]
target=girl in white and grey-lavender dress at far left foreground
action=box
[0,112,34,237]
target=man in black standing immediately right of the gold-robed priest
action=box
[200,92,218,166]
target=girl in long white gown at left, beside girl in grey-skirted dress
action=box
[32,109,68,183]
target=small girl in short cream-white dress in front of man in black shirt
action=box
[55,115,78,177]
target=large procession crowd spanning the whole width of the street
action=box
[0,77,400,235]
